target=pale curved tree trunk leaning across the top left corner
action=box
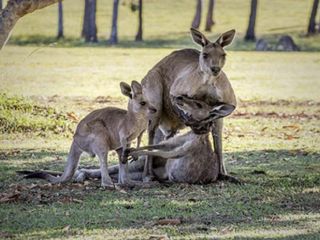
[0,0,59,49]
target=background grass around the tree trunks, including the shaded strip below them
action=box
[3,0,320,51]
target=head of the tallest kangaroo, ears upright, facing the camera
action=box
[191,28,236,76]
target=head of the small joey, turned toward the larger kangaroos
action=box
[120,81,148,114]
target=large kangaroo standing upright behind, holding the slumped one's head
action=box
[142,29,237,181]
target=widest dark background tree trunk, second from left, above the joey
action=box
[81,0,98,42]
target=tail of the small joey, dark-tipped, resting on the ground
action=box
[25,141,83,183]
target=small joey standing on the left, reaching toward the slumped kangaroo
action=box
[22,81,148,188]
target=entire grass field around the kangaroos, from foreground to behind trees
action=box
[0,0,320,239]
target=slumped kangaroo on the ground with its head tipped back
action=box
[72,97,234,184]
